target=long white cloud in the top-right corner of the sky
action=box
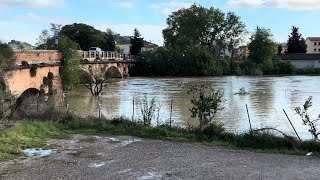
[227,0,320,10]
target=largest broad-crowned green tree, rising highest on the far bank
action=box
[163,4,245,54]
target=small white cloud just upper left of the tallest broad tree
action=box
[151,0,192,15]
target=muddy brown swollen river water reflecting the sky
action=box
[67,76,320,139]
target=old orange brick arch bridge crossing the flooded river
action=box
[4,50,134,100]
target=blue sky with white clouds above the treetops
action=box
[0,0,320,45]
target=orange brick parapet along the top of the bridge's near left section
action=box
[15,50,62,64]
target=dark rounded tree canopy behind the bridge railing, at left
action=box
[60,23,115,51]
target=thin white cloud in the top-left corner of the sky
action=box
[0,0,65,9]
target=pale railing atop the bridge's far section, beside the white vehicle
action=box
[79,51,134,61]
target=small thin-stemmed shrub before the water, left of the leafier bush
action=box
[141,96,156,126]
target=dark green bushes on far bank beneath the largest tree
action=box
[136,46,223,76]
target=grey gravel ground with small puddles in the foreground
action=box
[0,135,320,180]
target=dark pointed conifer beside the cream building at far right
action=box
[287,26,307,53]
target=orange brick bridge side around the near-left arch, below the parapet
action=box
[4,66,62,97]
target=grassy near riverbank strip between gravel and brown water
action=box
[0,118,320,161]
